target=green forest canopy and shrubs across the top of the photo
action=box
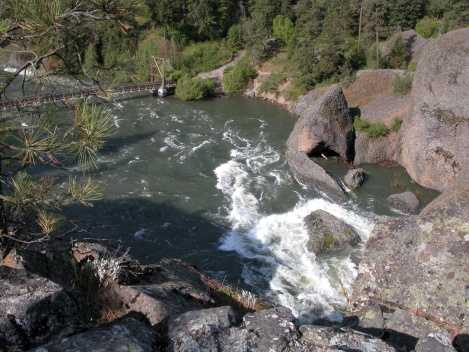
[0,0,469,93]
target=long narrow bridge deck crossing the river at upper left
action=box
[0,83,172,108]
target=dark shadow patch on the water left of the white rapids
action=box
[60,198,247,285]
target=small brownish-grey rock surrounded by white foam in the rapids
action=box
[304,209,360,253]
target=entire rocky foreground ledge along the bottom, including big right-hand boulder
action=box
[0,203,469,352]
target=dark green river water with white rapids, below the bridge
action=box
[0,73,436,321]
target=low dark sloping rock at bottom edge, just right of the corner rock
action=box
[31,318,159,352]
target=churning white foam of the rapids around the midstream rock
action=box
[215,153,374,321]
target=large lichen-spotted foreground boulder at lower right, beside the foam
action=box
[352,203,469,351]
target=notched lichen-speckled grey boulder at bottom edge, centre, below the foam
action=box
[167,307,300,352]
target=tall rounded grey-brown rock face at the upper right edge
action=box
[402,28,469,191]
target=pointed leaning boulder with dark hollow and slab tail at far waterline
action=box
[286,85,354,203]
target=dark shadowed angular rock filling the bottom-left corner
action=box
[0,266,90,352]
